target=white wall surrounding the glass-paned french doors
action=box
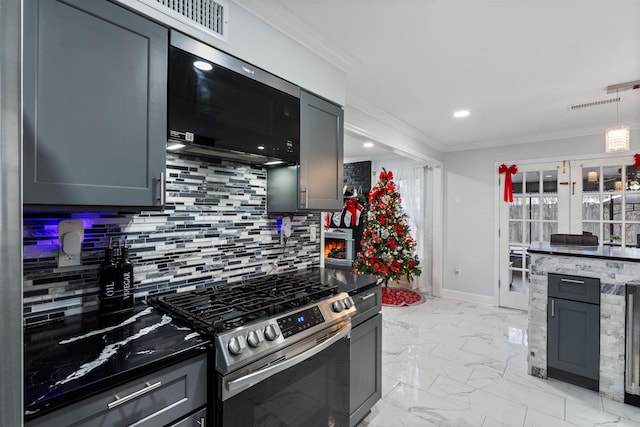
[443,130,640,303]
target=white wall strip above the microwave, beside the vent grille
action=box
[115,0,346,105]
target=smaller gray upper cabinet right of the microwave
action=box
[267,90,344,212]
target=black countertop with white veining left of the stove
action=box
[24,303,209,420]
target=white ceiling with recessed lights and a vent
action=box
[236,0,640,157]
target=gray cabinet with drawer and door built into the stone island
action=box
[547,274,600,390]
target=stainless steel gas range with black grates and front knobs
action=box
[153,271,356,427]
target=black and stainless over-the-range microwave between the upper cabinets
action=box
[167,31,300,165]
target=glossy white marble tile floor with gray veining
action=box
[358,297,640,427]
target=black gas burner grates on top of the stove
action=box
[151,271,338,335]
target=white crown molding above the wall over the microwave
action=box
[230,0,362,72]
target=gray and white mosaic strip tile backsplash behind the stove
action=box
[23,154,320,325]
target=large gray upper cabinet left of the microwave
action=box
[23,0,168,208]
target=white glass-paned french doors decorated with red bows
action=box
[499,157,640,310]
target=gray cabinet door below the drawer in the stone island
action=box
[547,298,600,380]
